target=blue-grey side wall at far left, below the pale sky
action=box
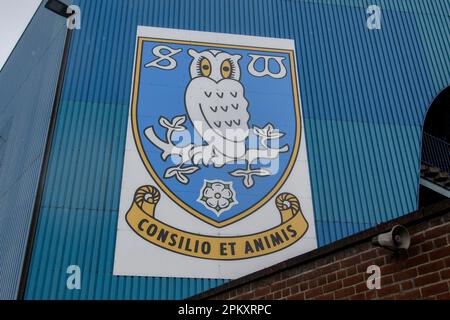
[0,2,66,300]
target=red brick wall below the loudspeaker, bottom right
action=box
[204,202,450,300]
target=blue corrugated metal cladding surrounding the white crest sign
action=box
[26,0,450,299]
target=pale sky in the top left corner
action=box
[0,0,41,69]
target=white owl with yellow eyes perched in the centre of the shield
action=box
[185,49,250,166]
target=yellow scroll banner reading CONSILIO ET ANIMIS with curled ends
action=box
[126,186,308,260]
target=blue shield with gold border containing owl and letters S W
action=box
[131,38,301,228]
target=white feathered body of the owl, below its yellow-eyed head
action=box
[186,78,250,141]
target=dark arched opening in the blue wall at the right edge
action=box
[419,87,450,208]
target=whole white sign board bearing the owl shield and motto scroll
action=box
[114,27,316,278]
